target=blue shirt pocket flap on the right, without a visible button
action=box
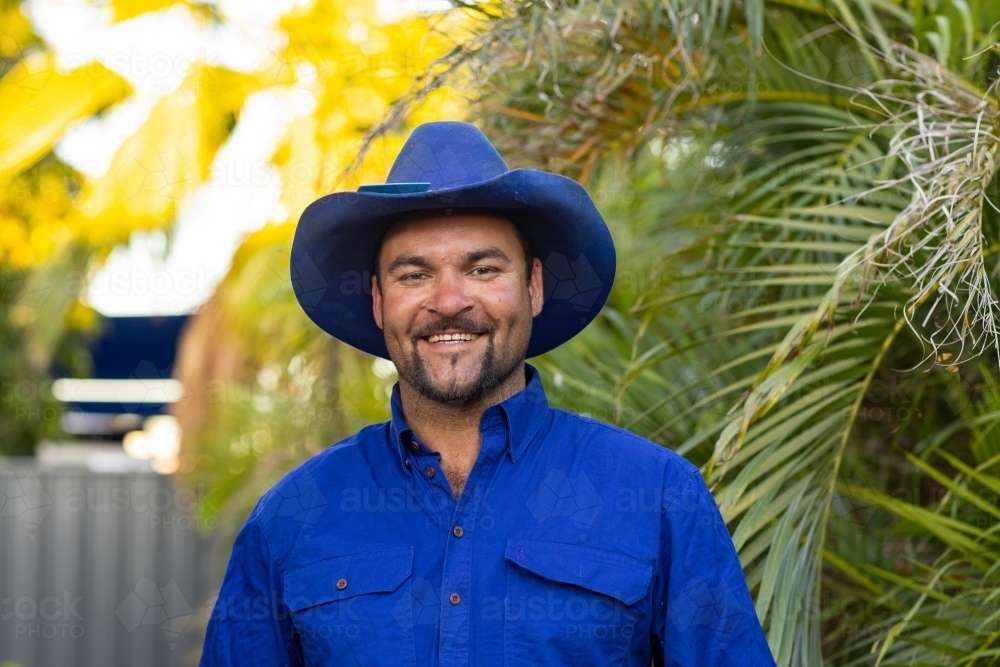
[504,540,653,604]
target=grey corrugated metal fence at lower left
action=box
[0,459,214,667]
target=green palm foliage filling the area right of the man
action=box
[370,0,1000,667]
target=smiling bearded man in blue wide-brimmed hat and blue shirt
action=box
[202,122,774,667]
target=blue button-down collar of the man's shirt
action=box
[389,363,549,474]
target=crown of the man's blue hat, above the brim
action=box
[386,120,507,190]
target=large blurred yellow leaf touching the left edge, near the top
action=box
[0,53,130,181]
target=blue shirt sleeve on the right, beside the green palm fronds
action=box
[653,470,775,667]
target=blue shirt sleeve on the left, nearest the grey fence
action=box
[200,512,303,667]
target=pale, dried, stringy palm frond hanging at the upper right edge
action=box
[851,43,1000,363]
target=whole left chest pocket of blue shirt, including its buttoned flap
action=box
[283,547,416,666]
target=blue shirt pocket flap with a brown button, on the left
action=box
[283,547,413,611]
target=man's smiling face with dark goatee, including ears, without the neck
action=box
[372,211,542,403]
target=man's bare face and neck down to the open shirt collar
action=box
[372,210,542,497]
